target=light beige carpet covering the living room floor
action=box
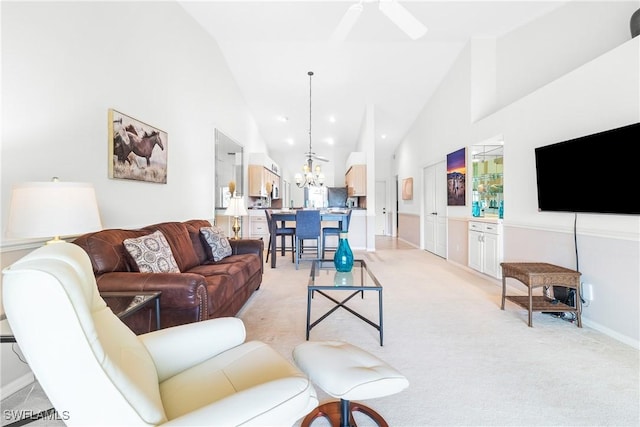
[239,249,640,427]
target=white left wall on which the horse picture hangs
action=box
[0,2,265,397]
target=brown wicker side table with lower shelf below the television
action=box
[500,262,582,328]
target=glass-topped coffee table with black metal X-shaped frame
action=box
[306,259,383,345]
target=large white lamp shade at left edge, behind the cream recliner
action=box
[6,181,102,238]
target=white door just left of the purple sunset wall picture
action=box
[424,161,447,258]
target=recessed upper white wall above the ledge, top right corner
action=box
[496,1,639,107]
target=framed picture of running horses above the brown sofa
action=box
[107,109,169,184]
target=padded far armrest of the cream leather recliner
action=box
[138,317,246,381]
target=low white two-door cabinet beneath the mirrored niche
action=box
[469,221,503,279]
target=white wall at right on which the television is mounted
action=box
[395,2,640,347]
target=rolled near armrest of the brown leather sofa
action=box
[96,271,208,310]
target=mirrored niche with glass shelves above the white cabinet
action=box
[471,137,504,216]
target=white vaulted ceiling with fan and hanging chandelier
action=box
[180,0,566,161]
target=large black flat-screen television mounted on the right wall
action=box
[535,123,640,215]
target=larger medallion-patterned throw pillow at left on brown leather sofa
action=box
[123,231,180,273]
